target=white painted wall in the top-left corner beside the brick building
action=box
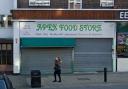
[0,0,14,15]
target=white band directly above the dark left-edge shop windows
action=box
[0,28,13,38]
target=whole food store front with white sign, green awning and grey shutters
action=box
[14,21,116,74]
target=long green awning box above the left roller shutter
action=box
[20,38,75,47]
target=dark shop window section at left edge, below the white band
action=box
[0,39,13,73]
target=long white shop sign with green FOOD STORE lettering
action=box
[20,21,115,38]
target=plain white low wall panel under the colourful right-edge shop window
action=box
[117,58,128,72]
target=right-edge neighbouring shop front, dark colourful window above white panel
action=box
[117,22,128,72]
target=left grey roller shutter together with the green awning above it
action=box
[21,38,75,74]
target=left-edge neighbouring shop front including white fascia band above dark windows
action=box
[0,27,13,74]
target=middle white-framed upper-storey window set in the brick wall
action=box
[69,0,82,9]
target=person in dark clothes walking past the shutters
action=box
[53,57,62,82]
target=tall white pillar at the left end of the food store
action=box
[13,22,21,74]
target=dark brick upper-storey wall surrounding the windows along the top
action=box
[18,0,128,9]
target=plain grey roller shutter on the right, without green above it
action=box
[74,38,112,72]
